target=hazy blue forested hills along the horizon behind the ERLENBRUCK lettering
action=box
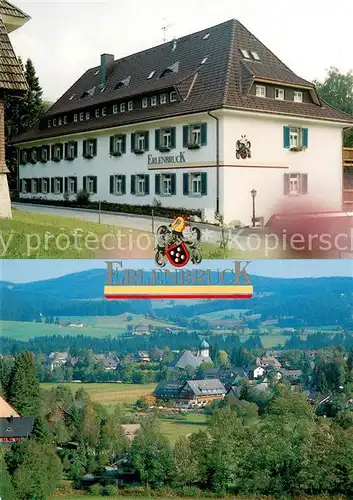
[0,269,353,326]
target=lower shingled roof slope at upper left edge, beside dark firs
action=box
[0,19,27,94]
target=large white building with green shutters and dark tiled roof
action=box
[14,20,353,225]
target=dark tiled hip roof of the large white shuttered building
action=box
[15,20,353,142]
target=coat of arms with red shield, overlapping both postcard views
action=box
[154,215,202,267]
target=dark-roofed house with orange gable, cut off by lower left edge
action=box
[0,396,34,444]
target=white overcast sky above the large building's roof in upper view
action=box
[11,0,353,101]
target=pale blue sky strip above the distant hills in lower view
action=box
[0,259,353,283]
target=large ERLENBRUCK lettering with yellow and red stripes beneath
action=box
[104,261,253,300]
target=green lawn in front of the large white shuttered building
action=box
[0,209,154,259]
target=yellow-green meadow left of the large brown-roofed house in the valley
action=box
[41,382,156,407]
